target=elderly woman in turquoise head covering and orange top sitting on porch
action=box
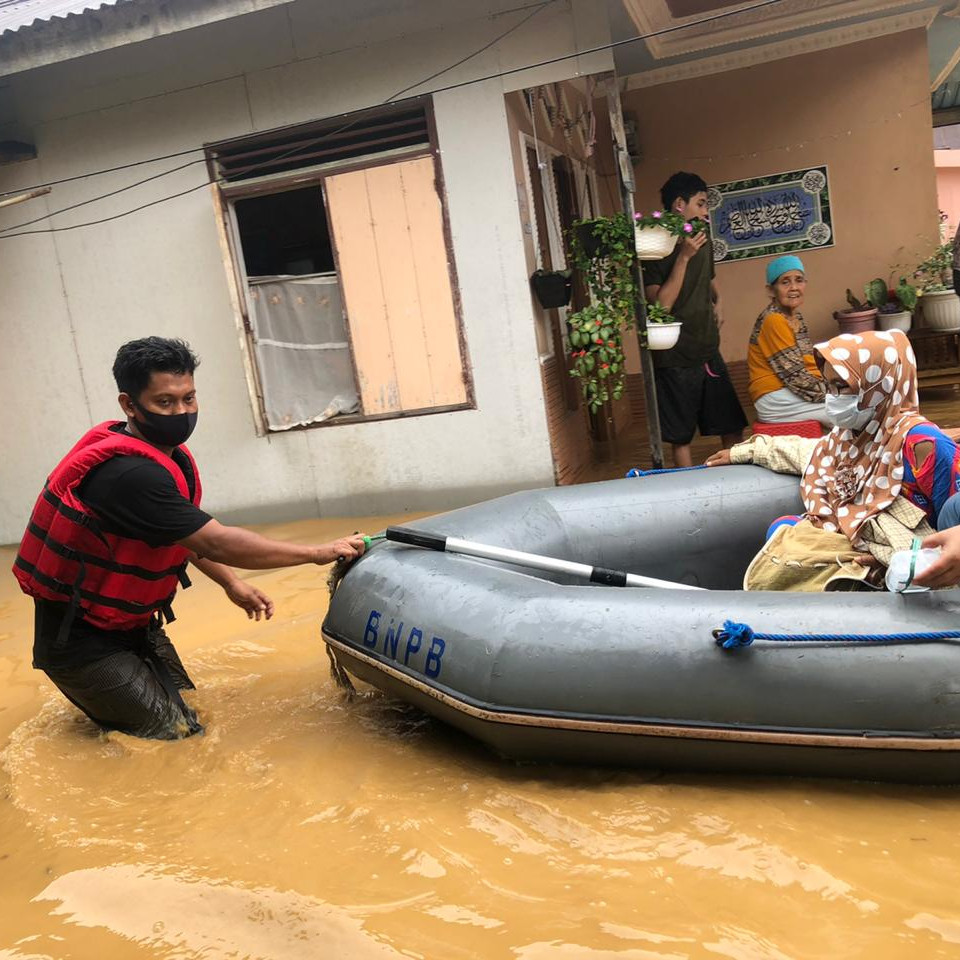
[747,256,829,424]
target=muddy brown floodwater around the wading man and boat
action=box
[0,517,960,960]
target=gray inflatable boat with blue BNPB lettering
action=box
[323,466,960,783]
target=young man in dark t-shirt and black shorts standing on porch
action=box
[643,173,747,467]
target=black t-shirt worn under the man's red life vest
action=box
[33,425,212,669]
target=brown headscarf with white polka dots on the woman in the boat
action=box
[801,330,926,543]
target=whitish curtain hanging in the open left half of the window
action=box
[250,274,360,430]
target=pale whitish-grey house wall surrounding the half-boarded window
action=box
[0,0,609,542]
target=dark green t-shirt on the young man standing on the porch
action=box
[643,239,720,367]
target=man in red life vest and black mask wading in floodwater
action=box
[13,337,364,740]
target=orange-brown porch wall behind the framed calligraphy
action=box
[616,30,938,373]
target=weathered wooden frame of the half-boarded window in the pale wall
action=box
[213,98,477,437]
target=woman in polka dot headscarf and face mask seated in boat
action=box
[707,330,960,590]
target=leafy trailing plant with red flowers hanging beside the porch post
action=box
[567,213,637,414]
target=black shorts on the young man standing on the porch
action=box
[654,353,747,446]
